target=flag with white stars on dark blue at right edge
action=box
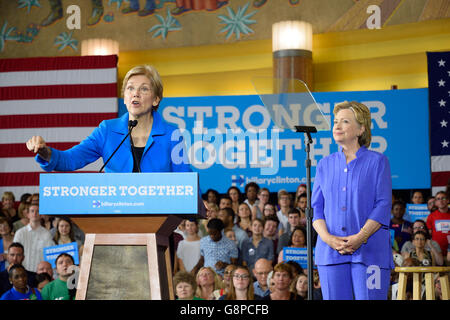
[427,52,450,195]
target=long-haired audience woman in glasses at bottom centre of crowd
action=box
[219,266,260,300]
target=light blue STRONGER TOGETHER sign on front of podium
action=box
[39,172,198,215]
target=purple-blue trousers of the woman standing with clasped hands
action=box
[317,263,391,300]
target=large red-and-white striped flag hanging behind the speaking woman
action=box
[0,55,118,201]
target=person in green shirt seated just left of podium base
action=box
[41,253,75,300]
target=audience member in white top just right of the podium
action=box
[177,219,200,272]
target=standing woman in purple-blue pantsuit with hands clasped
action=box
[311,101,394,300]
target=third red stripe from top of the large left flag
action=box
[0,111,117,129]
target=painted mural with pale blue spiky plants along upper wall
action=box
[0,0,450,58]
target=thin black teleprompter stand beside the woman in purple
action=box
[295,126,317,300]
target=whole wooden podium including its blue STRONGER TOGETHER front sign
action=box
[39,172,206,300]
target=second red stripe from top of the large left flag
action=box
[0,83,117,100]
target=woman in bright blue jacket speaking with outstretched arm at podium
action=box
[26,65,191,172]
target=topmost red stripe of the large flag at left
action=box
[0,55,118,72]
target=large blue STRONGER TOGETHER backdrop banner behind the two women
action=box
[119,89,431,193]
